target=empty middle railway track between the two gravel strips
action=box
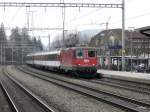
[15,67,150,112]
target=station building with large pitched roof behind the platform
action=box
[89,29,150,70]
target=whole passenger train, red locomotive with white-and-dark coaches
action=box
[26,47,98,77]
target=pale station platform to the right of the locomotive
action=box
[97,69,150,84]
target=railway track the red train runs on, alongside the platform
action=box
[24,65,150,95]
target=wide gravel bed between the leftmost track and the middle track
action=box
[8,67,125,112]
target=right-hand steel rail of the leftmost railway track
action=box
[4,67,56,112]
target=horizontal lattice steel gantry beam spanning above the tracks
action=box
[0,2,123,8]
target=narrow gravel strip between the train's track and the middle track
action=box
[24,65,150,103]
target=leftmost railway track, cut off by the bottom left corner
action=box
[1,67,56,112]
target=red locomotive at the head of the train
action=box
[60,47,98,75]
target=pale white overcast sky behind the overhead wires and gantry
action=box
[0,0,150,47]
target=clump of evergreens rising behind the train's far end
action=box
[10,27,43,64]
